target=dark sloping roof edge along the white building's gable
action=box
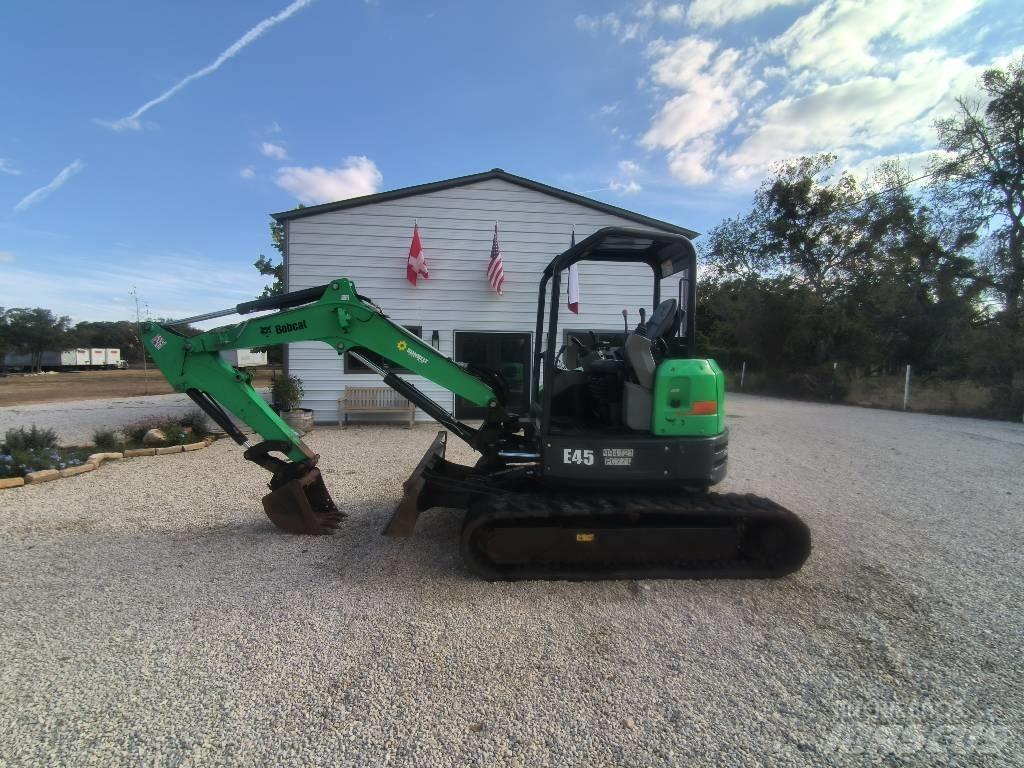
[270,168,698,238]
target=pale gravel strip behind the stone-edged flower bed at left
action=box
[0,389,270,445]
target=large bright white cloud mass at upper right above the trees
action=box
[638,0,1011,186]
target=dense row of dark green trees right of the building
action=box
[697,58,1024,419]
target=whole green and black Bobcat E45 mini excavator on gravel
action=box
[142,227,811,580]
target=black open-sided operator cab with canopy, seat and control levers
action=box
[531,227,696,434]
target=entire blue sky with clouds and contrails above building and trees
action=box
[0,0,1024,319]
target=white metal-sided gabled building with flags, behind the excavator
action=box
[273,168,695,423]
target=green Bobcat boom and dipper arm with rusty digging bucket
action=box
[142,279,506,534]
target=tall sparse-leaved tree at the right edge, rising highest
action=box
[931,57,1024,331]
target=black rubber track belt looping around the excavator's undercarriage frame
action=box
[461,493,811,581]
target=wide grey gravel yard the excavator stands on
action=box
[0,396,1024,766]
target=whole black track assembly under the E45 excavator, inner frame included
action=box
[461,493,811,581]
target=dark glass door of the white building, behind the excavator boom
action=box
[455,331,530,419]
